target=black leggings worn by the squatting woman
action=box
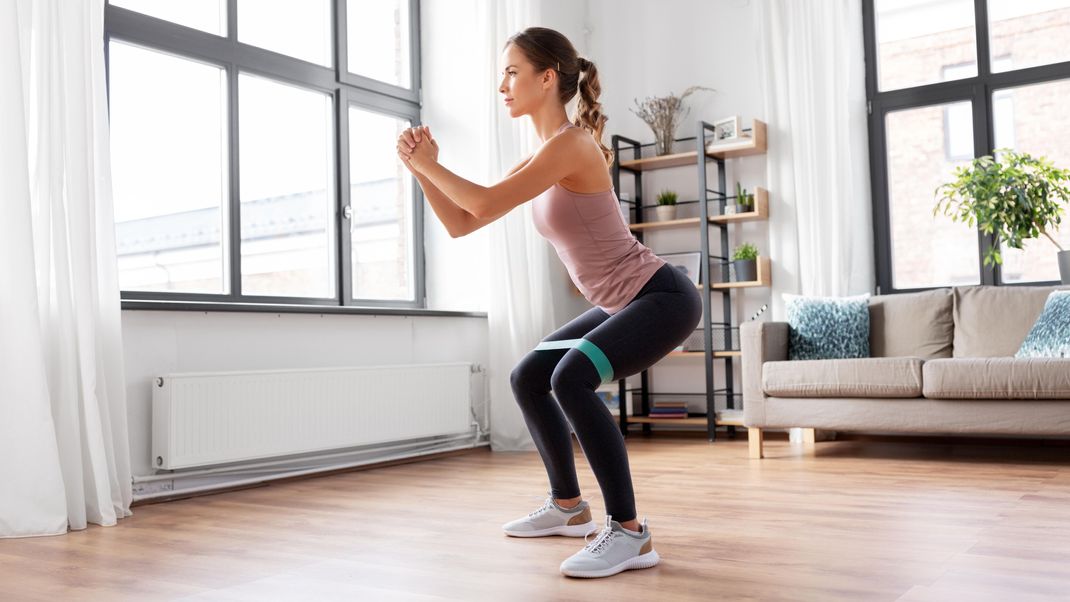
[510,264,702,522]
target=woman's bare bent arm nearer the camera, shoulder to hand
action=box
[410,136,582,218]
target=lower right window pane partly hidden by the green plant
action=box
[992,79,1070,282]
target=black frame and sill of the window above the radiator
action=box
[104,0,425,315]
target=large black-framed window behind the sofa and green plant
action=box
[863,0,1070,293]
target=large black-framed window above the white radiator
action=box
[105,0,424,308]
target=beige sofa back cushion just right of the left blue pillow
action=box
[869,289,954,359]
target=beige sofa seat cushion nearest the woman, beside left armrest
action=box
[762,357,922,398]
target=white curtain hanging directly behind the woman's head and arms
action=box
[477,0,555,451]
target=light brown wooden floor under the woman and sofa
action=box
[0,435,1070,602]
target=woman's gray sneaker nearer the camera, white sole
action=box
[561,515,660,577]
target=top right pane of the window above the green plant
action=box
[989,0,1070,72]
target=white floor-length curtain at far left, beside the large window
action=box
[0,0,132,538]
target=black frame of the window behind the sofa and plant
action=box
[862,0,1070,294]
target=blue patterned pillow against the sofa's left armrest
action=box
[783,293,869,359]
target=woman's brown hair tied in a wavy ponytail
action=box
[505,27,613,165]
